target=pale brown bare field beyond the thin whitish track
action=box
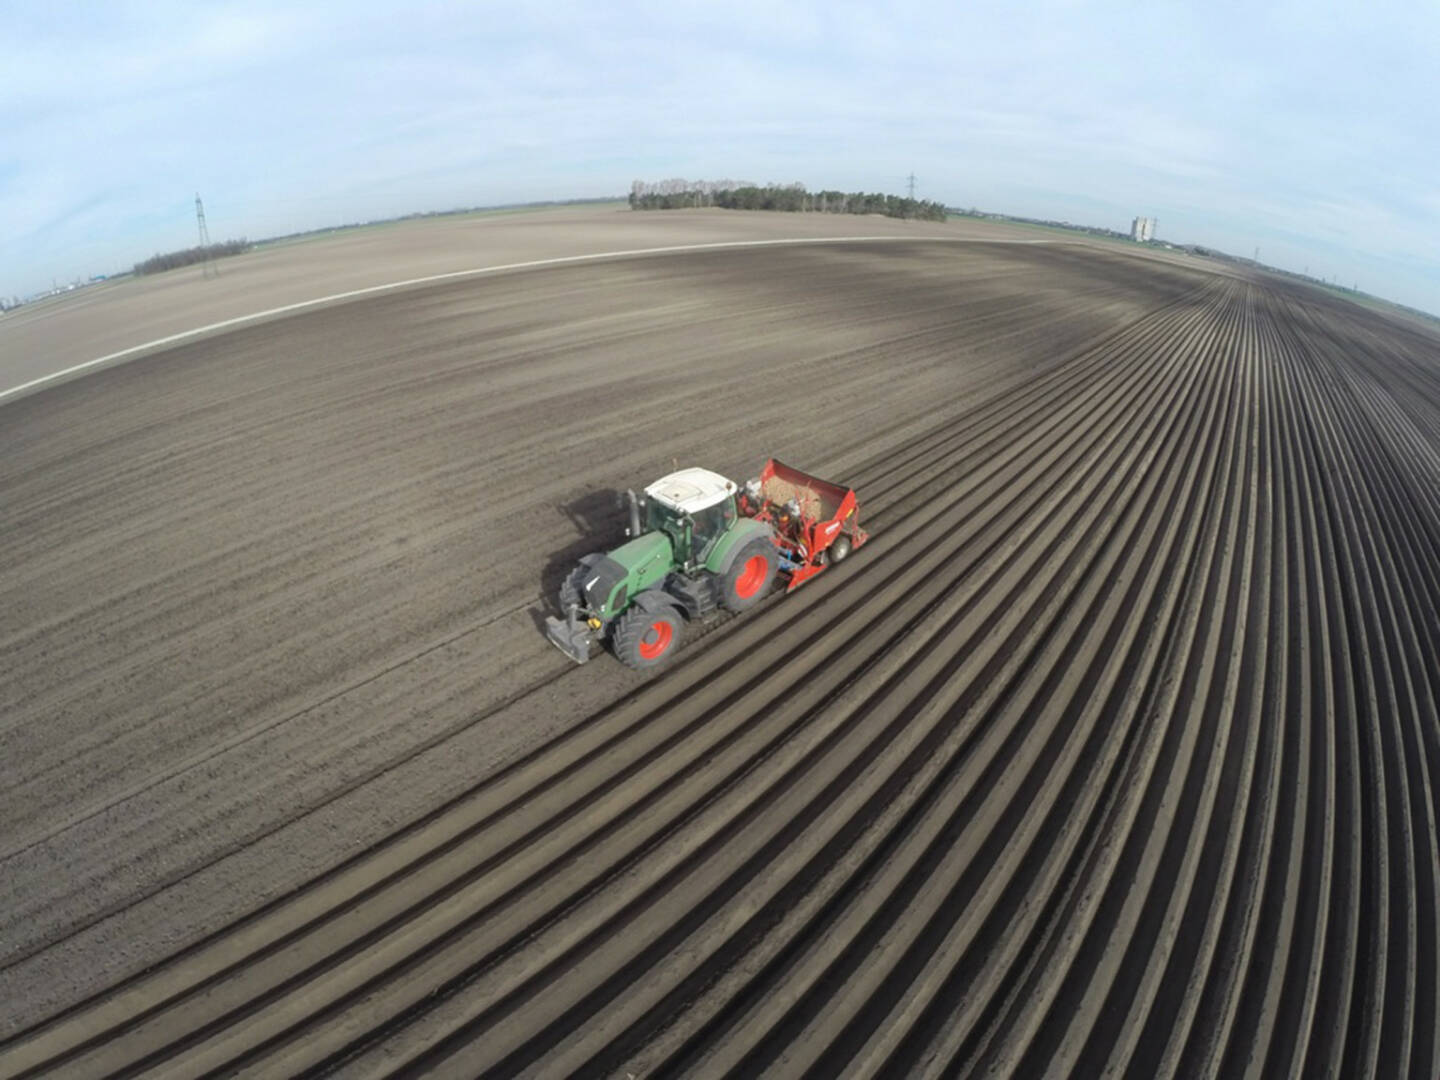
[0,206,1123,396]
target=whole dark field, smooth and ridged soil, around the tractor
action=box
[0,240,1440,1077]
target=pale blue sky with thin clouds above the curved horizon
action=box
[0,0,1440,312]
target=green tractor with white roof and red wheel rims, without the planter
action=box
[546,468,780,670]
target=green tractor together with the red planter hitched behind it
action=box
[546,458,867,671]
